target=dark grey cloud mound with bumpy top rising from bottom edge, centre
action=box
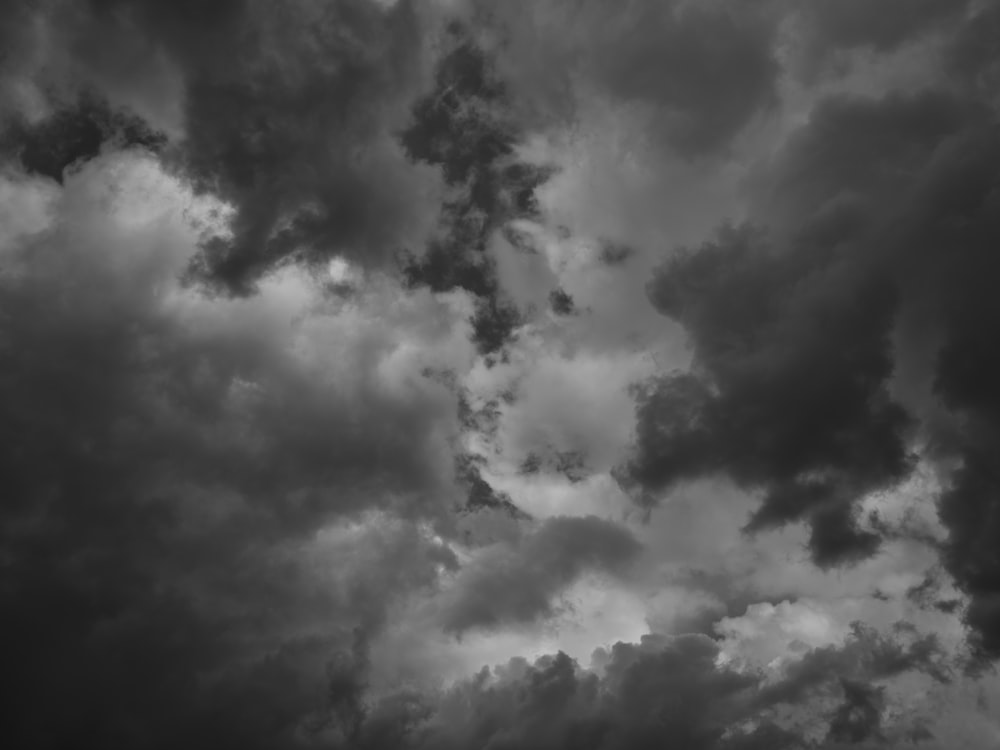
[398,636,755,750]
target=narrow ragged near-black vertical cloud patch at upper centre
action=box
[400,24,552,354]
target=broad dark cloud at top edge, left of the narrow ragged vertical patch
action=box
[183,0,434,288]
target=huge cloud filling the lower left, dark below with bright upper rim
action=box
[0,151,456,748]
